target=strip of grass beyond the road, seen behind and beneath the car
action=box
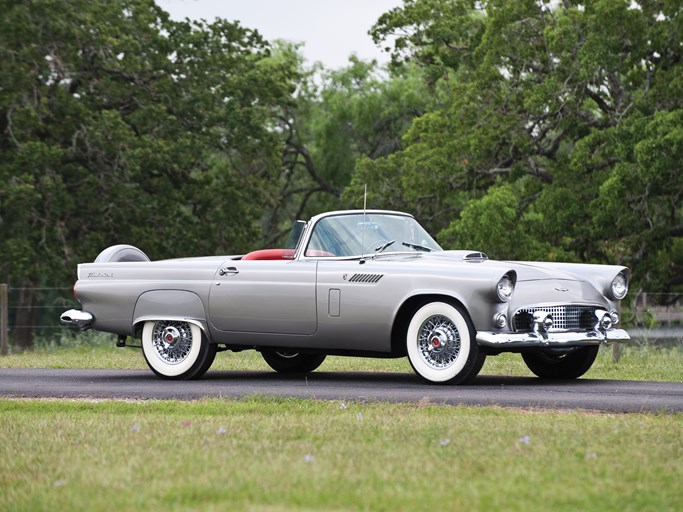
[0,333,683,382]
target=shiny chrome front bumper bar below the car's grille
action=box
[477,329,631,348]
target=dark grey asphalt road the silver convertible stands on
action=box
[0,368,683,412]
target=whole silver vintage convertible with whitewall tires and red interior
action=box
[61,210,629,384]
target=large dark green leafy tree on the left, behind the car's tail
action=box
[0,0,296,347]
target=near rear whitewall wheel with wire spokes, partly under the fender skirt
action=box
[142,320,216,380]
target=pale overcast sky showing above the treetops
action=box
[156,0,402,69]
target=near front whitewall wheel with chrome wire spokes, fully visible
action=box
[406,302,486,384]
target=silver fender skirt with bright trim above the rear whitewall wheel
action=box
[133,290,209,336]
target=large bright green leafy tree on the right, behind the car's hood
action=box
[347,0,683,291]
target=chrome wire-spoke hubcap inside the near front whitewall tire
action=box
[417,315,460,370]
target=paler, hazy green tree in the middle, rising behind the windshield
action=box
[266,55,432,243]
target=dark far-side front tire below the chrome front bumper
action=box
[522,345,600,379]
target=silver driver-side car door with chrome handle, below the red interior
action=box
[209,260,317,335]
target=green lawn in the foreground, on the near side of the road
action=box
[0,398,683,511]
